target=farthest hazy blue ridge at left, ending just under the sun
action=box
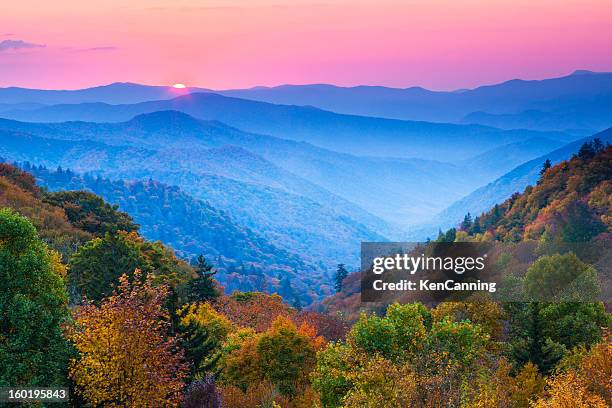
[0,82,208,104]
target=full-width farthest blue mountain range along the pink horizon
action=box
[0,70,612,132]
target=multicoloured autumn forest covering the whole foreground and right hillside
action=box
[0,140,612,408]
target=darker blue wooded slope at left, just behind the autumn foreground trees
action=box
[16,164,327,304]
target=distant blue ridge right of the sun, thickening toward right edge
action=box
[216,70,612,130]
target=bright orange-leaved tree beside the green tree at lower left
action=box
[69,271,187,407]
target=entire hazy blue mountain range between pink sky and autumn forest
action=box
[0,71,612,302]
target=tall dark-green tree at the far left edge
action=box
[0,209,69,387]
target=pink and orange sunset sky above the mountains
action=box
[0,0,612,90]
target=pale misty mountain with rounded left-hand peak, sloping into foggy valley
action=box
[0,111,558,228]
